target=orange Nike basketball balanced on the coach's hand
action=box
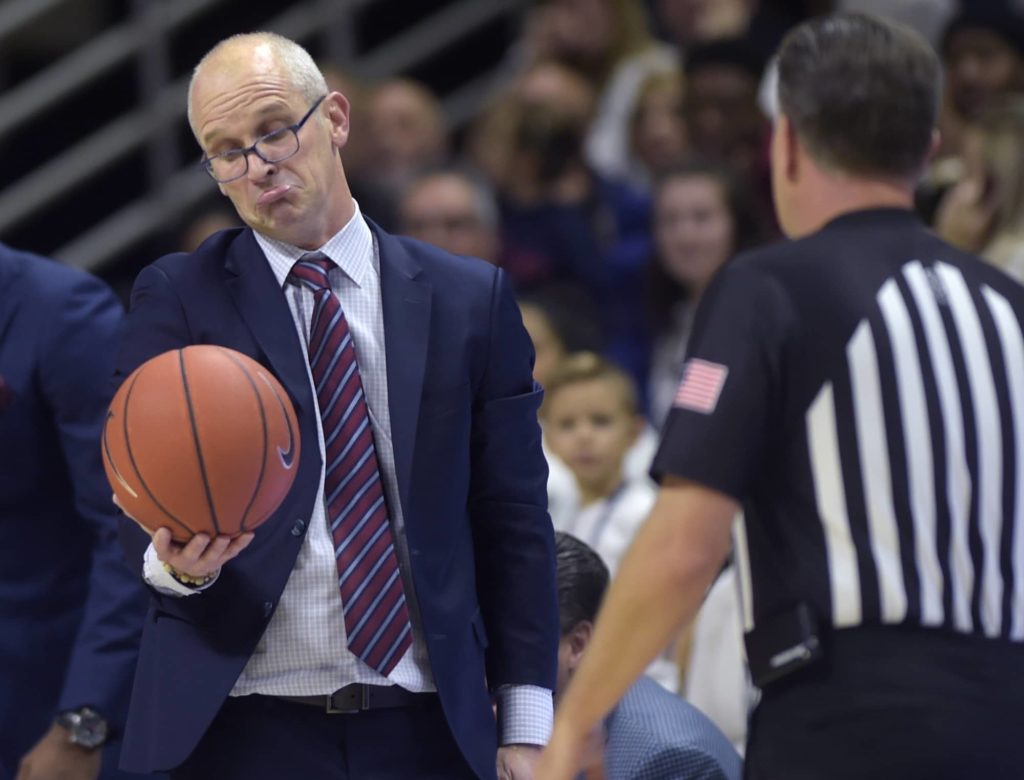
[102,345,299,541]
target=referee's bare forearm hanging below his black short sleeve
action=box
[536,477,739,780]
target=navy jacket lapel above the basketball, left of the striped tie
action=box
[224,229,307,414]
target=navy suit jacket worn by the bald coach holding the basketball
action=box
[119,225,558,778]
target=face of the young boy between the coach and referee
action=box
[544,379,638,493]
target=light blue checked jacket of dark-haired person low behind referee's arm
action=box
[604,677,743,780]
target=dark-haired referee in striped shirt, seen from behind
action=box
[538,13,1024,780]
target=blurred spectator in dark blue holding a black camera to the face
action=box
[491,63,650,395]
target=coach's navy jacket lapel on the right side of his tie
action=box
[367,220,432,514]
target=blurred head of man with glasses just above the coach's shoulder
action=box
[398,169,500,265]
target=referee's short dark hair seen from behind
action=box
[778,13,942,178]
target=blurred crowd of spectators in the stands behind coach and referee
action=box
[174,0,1024,746]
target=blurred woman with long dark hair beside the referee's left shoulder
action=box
[646,162,758,428]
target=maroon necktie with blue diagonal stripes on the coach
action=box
[290,252,413,676]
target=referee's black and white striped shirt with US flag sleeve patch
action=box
[654,210,1024,641]
